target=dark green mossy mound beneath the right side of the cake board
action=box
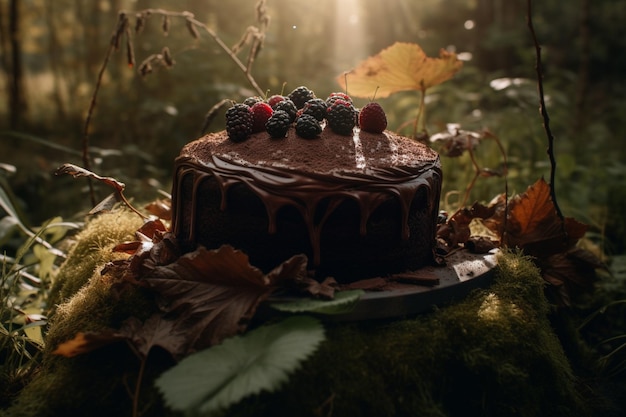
[228,250,592,416]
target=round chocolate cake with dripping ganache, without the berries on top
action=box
[172,122,442,282]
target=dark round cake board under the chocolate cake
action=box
[270,249,497,321]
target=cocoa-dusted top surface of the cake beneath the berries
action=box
[180,127,439,173]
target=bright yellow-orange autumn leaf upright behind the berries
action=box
[337,42,463,98]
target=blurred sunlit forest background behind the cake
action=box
[0,0,626,255]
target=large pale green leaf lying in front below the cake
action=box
[156,316,324,415]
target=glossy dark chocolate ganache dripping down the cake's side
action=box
[172,155,441,265]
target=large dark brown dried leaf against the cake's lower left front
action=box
[141,246,307,351]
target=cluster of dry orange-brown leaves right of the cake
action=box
[437,179,604,305]
